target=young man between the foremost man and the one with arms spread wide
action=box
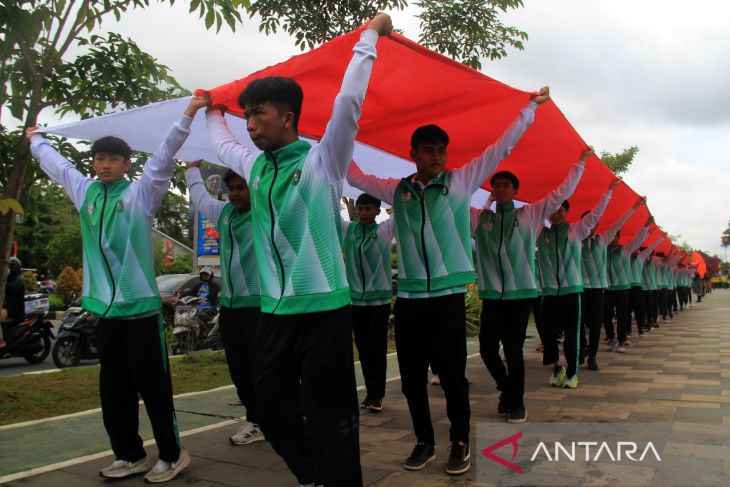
[342,193,395,412]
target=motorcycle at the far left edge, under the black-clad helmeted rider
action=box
[0,310,54,364]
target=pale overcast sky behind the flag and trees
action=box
[34,0,730,256]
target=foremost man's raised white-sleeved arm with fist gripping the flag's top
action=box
[313,13,393,183]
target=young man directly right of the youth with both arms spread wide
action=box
[471,151,593,423]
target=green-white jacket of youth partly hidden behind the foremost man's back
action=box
[185,167,261,309]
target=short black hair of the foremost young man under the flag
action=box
[238,76,304,129]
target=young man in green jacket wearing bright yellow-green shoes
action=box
[537,173,620,389]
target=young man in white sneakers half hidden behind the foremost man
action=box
[185,161,264,445]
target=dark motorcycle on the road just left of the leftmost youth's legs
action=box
[53,307,99,369]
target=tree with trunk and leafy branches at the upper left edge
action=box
[0,0,248,304]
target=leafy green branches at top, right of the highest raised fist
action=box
[415,0,527,69]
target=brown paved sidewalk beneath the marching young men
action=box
[0,291,730,487]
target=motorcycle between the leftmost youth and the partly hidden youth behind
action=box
[170,296,222,355]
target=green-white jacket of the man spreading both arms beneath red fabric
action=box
[347,102,537,299]
